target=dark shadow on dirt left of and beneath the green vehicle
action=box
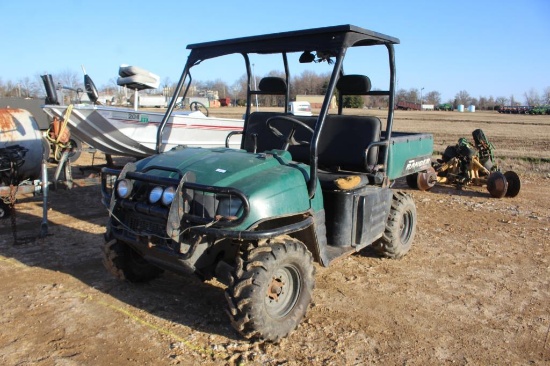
[0,177,239,339]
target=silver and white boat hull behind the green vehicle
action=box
[42,105,243,157]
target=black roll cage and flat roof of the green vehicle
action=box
[156,25,399,198]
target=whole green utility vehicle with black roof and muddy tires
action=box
[102,25,433,341]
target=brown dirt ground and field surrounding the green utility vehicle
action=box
[0,111,550,365]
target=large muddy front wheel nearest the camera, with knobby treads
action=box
[225,236,315,341]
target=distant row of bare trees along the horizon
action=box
[0,70,550,110]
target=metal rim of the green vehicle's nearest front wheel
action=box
[265,266,301,318]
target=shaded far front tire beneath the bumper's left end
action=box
[103,240,164,282]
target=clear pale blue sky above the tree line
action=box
[0,0,550,101]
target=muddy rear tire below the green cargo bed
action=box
[373,192,416,259]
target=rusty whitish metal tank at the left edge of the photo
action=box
[0,108,49,181]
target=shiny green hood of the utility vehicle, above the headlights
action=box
[132,148,311,228]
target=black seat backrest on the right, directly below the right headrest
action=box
[317,115,382,172]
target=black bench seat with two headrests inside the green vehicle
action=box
[243,75,382,190]
